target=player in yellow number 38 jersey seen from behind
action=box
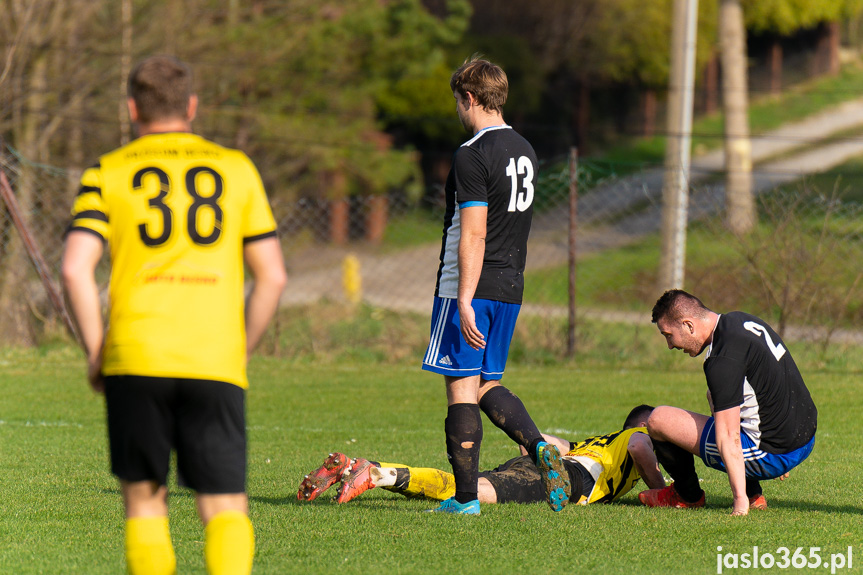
[62,56,287,575]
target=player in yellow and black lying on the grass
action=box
[297,405,665,505]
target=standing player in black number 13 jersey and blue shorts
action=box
[423,58,570,515]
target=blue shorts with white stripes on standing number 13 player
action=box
[423,297,521,381]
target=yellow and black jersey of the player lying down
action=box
[564,427,647,504]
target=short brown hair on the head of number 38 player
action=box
[127,56,194,124]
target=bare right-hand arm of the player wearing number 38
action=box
[243,237,288,358]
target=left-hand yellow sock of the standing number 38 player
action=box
[126,517,177,575]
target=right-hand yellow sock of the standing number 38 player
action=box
[204,511,255,575]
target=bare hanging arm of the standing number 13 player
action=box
[458,205,488,349]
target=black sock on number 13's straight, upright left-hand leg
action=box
[444,403,482,503]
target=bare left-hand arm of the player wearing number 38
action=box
[62,230,104,392]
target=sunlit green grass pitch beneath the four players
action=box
[0,342,863,575]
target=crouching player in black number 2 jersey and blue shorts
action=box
[639,290,818,515]
